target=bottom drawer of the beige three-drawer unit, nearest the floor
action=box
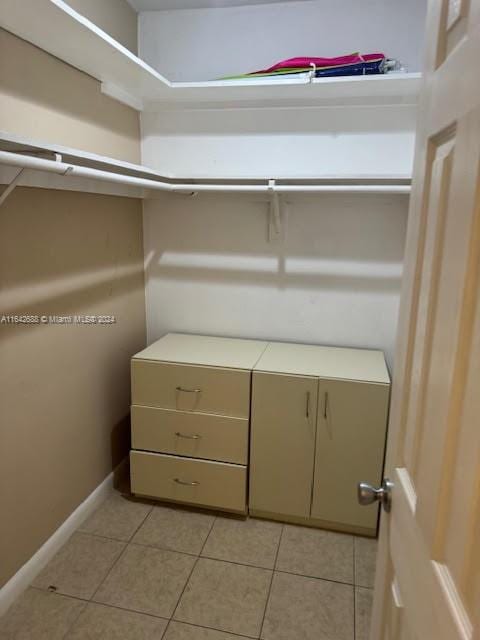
[130,451,247,513]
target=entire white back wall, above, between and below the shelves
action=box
[139,0,416,363]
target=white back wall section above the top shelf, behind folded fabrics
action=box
[139,0,427,81]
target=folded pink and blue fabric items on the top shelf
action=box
[223,53,387,80]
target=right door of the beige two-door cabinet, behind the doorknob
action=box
[312,380,390,530]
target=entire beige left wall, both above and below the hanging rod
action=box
[0,20,145,586]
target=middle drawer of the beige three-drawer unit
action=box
[132,405,248,464]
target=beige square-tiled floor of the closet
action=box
[0,484,376,640]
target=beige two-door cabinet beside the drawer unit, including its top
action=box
[249,343,390,535]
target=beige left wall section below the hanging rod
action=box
[0,188,145,586]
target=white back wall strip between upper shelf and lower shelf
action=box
[141,105,416,178]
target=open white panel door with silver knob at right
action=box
[371,0,480,640]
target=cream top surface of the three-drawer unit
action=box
[133,333,268,370]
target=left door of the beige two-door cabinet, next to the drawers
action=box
[249,372,318,518]
